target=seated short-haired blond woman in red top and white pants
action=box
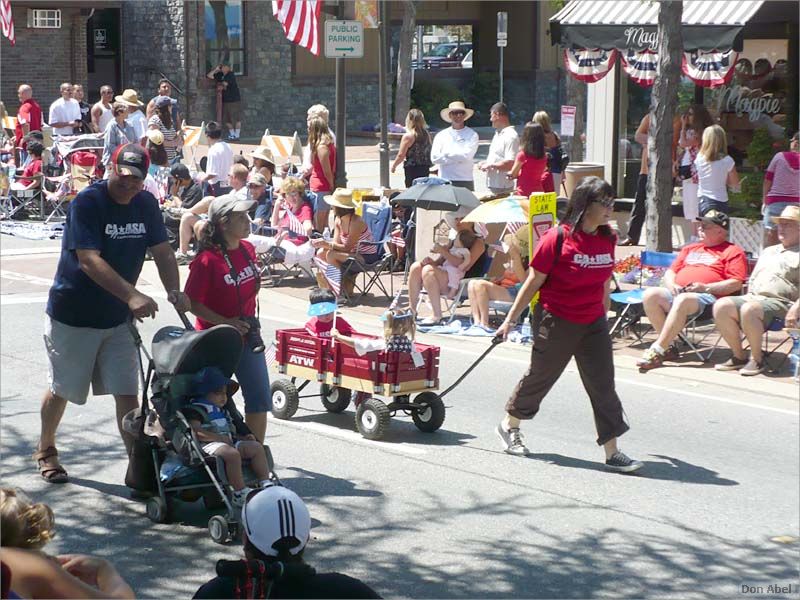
[247,177,314,265]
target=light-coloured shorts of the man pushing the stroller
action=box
[44,315,139,404]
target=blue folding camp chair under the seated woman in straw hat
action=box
[342,202,394,304]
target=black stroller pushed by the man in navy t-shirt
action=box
[125,315,280,544]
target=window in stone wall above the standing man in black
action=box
[204,0,245,75]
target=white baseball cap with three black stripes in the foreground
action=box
[242,485,311,556]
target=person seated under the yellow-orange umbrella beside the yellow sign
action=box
[467,227,529,330]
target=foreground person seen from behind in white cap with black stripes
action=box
[194,486,380,598]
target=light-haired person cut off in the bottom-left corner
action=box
[0,488,134,598]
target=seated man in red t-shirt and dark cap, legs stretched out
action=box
[636,209,747,372]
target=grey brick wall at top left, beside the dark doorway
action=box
[0,2,88,119]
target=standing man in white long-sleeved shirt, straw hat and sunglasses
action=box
[431,102,478,190]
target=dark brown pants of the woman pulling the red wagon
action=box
[506,305,629,446]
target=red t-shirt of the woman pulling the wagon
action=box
[530,225,617,323]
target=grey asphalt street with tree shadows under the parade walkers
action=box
[0,235,800,598]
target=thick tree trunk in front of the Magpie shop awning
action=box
[645,0,683,252]
